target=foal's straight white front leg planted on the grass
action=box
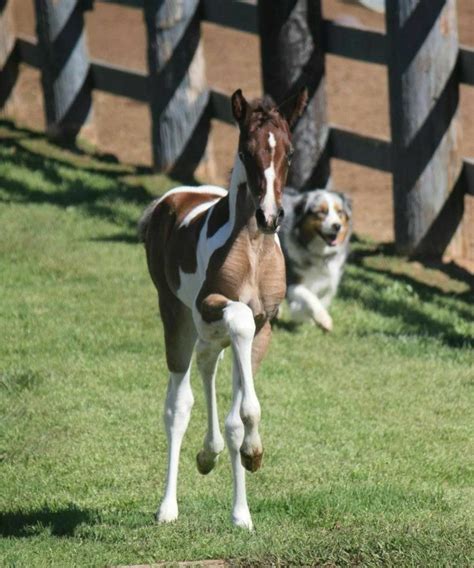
[225,355,253,530]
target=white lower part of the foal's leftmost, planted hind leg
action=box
[156,366,194,522]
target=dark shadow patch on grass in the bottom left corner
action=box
[0,504,97,538]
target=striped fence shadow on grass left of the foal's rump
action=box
[0,120,177,237]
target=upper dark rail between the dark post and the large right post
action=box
[323,20,387,65]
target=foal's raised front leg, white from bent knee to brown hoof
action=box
[223,302,263,470]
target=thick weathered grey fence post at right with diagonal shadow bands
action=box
[386,0,463,257]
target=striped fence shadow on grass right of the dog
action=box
[274,237,474,348]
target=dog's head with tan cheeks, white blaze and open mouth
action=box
[293,189,352,247]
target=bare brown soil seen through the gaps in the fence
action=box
[6,0,474,269]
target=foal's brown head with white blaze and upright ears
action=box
[232,89,307,233]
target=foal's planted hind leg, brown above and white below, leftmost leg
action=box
[156,299,196,522]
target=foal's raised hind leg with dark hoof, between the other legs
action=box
[196,340,224,475]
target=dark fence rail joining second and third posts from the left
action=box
[91,59,150,102]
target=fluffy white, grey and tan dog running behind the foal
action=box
[279,188,352,331]
